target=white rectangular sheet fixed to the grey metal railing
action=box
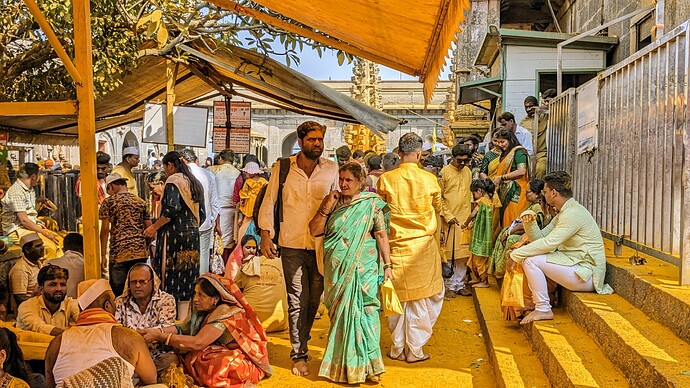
[577,78,599,155]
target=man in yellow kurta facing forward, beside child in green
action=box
[438,144,472,298]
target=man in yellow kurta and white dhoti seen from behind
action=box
[376,133,444,362]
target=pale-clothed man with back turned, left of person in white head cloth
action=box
[208,150,241,249]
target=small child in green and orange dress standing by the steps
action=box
[462,179,497,288]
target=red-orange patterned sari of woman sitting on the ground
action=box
[178,273,272,387]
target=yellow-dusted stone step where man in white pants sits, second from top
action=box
[562,290,690,388]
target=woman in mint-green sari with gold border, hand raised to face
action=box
[309,163,393,384]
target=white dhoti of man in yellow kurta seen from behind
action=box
[388,290,445,358]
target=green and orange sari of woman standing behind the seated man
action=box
[496,146,529,228]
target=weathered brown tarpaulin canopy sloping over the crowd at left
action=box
[0,44,400,144]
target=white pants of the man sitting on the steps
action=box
[522,255,594,312]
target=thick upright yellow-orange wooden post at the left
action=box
[72,0,101,279]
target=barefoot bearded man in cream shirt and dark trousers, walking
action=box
[258,121,339,376]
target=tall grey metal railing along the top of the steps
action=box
[548,21,690,284]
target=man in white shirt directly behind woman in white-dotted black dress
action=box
[182,148,220,275]
